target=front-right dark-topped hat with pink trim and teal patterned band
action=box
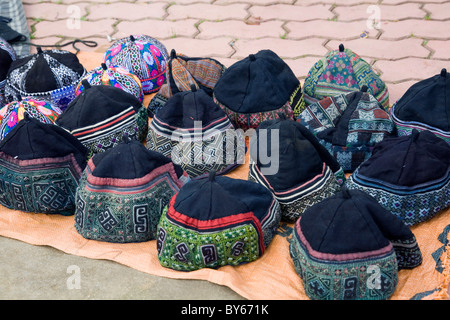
[289,188,422,300]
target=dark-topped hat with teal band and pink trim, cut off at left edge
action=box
[0,114,87,215]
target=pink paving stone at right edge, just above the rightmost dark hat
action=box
[374,58,450,83]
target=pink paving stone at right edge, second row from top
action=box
[380,19,450,40]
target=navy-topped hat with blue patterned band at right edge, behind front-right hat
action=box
[346,130,450,226]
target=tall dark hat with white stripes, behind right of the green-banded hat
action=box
[248,114,345,222]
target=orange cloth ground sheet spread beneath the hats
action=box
[0,52,450,300]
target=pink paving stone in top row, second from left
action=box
[88,2,168,21]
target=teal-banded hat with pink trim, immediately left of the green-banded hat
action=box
[75,136,189,243]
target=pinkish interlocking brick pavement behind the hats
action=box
[23,0,450,103]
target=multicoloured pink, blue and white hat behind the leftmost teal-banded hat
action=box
[0,98,62,140]
